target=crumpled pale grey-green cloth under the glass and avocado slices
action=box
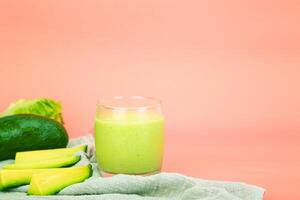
[0,135,264,200]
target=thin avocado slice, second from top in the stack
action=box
[2,156,81,169]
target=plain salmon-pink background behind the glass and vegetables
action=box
[0,0,300,200]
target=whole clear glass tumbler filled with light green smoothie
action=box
[95,96,164,176]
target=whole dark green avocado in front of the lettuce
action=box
[0,114,69,160]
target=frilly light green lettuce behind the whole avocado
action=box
[1,98,63,124]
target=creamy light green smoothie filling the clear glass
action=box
[95,117,164,174]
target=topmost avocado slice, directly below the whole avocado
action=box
[15,145,87,164]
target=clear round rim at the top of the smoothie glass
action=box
[97,95,162,110]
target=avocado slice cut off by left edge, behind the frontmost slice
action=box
[0,168,68,190]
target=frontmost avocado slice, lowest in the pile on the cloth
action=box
[28,165,92,195]
